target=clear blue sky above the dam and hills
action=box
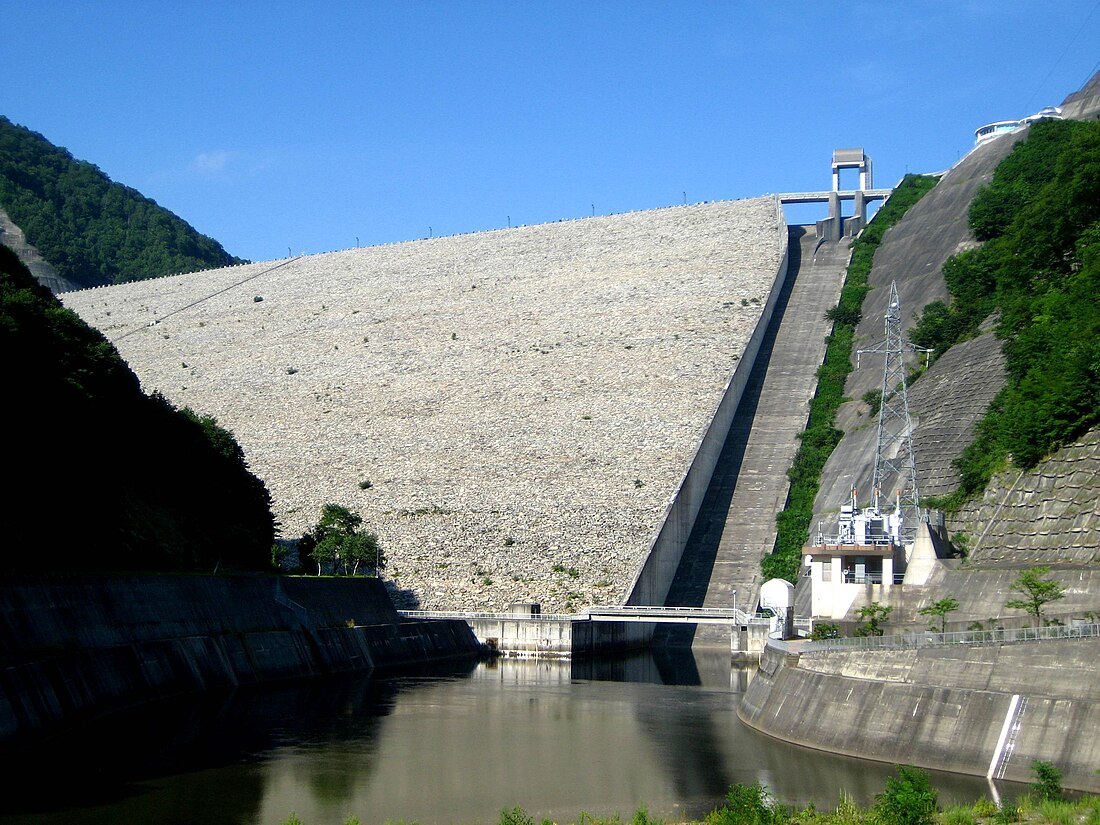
[0,0,1100,261]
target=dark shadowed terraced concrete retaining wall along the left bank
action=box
[0,575,479,741]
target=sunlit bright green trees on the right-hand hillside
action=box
[911,120,1100,506]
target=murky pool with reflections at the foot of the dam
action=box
[0,655,1020,825]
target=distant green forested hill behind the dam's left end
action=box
[0,116,242,286]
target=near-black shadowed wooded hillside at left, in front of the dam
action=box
[0,245,275,573]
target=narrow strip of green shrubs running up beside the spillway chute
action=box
[760,175,937,582]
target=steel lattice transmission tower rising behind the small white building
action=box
[856,282,932,545]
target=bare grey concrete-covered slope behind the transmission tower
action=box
[814,73,1100,536]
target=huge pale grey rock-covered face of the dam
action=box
[63,198,787,611]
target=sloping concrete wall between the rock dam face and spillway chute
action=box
[625,199,789,605]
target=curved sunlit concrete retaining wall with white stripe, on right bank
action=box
[738,640,1100,791]
